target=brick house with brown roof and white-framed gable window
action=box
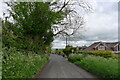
[83,42,120,53]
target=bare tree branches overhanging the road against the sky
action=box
[48,0,92,36]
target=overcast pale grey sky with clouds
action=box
[0,0,119,48]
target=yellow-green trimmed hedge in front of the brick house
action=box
[77,50,113,58]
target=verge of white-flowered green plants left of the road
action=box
[2,48,49,78]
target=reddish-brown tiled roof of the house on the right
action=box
[84,42,120,51]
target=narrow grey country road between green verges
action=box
[39,54,96,78]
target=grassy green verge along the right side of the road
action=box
[68,55,119,80]
